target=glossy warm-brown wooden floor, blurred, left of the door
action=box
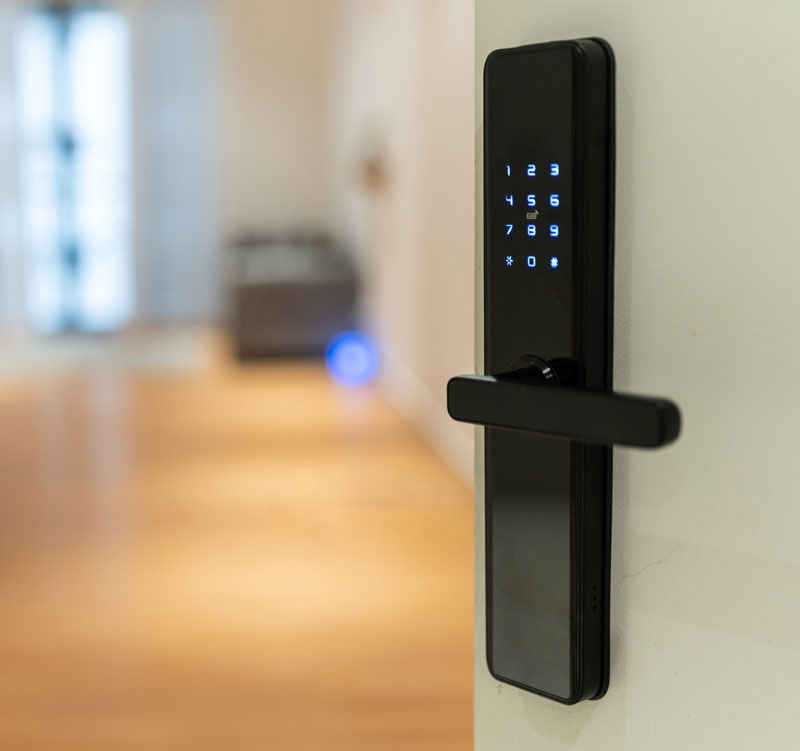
[0,336,472,751]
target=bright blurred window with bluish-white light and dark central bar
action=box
[16,4,133,332]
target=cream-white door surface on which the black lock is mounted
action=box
[475,0,800,751]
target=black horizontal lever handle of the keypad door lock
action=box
[447,375,681,448]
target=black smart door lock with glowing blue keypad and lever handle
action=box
[448,39,680,704]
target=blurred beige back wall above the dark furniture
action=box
[218,0,337,235]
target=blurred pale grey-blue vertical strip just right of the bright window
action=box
[130,0,222,323]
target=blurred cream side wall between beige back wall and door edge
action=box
[331,0,474,478]
